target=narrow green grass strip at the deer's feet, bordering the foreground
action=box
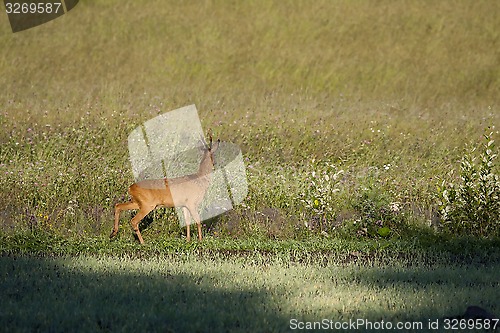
[0,228,500,265]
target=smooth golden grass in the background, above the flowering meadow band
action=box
[1,0,500,105]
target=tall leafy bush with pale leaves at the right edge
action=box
[438,132,500,237]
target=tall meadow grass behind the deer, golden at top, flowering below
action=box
[0,1,500,239]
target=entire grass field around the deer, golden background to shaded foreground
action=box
[0,0,500,332]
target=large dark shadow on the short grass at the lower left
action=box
[0,256,288,332]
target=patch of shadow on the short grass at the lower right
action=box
[353,263,500,332]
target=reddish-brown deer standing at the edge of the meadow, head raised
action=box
[109,133,220,244]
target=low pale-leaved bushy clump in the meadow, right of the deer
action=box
[299,160,405,238]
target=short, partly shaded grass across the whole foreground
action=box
[0,256,500,332]
